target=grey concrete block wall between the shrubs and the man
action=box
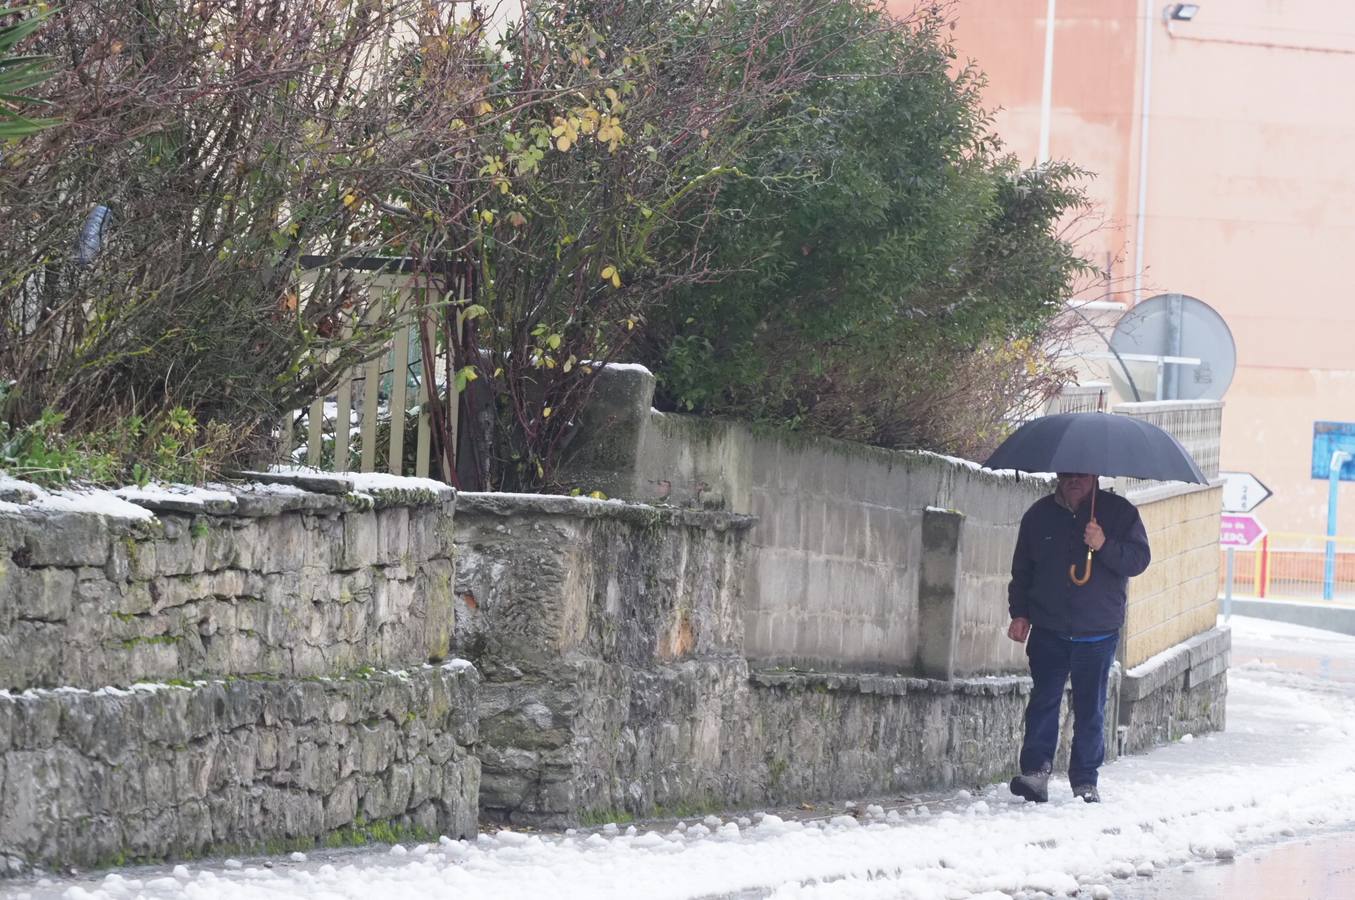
[566,370,1049,675]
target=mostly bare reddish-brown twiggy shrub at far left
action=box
[0,0,498,474]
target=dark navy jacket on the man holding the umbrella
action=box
[1007,491,1150,636]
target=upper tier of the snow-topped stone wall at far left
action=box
[0,487,454,690]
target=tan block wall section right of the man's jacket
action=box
[1122,485,1222,667]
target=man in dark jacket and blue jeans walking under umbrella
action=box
[1007,473,1150,804]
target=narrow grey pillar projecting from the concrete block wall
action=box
[917,508,965,680]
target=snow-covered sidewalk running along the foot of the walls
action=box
[8,617,1355,900]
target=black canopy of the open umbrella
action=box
[984,412,1209,484]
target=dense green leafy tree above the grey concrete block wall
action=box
[634,0,1087,450]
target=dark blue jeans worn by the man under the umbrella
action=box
[1020,628,1119,786]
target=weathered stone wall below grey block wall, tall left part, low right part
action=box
[455,493,1118,827]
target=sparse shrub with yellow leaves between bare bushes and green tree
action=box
[417,0,867,489]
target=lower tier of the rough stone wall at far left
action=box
[0,664,478,872]
